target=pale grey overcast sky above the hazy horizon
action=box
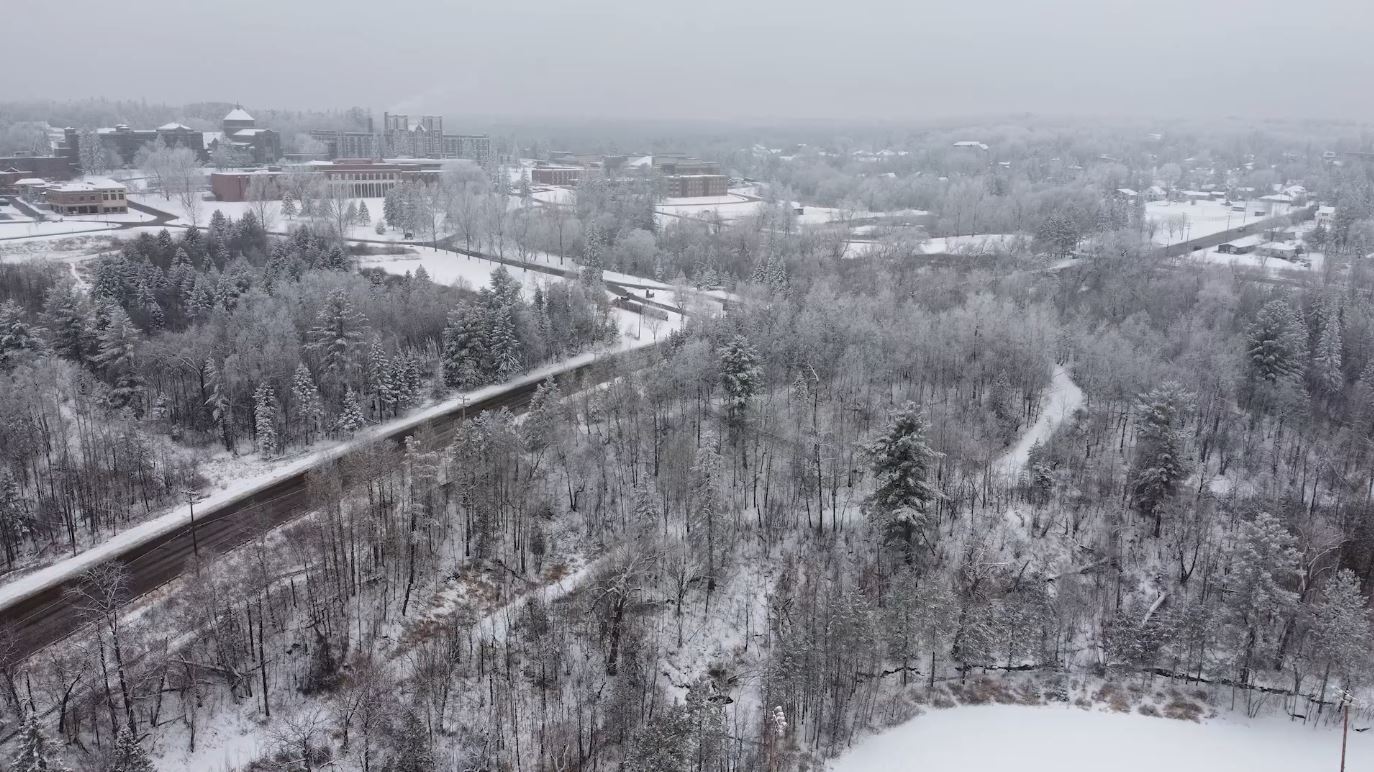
[10,0,1374,121]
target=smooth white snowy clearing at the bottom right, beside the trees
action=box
[830,705,1357,772]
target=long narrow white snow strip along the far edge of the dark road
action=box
[0,337,653,606]
